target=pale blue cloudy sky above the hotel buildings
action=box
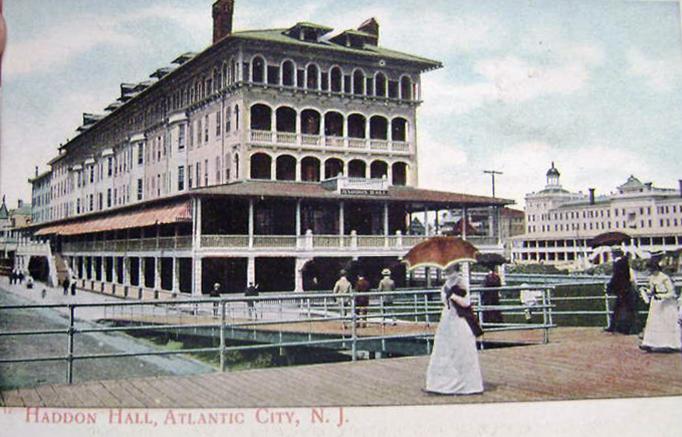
[0,0,682,207]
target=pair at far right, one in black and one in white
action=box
[605,250,682,352]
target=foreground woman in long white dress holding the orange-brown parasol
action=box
[426,267,483,395]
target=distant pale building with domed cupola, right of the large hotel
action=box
[512,163,682,264]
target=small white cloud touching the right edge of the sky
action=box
[626,48,682,93]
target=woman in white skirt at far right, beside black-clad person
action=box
[640,260,681,351]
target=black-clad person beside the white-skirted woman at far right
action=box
[604,250,637,335]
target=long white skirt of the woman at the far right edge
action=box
[642,299,681,350]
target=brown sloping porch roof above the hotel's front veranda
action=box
[191,180,514,208]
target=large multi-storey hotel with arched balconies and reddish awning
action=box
[24,0,511,295]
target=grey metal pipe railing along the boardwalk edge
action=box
[0,286,555,384]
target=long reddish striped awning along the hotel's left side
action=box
[35,201,192,236]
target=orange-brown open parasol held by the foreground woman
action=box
[403,237,478,270]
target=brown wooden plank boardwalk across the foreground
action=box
[0,328,682,408]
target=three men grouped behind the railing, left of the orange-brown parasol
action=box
[332,269,395,328]
